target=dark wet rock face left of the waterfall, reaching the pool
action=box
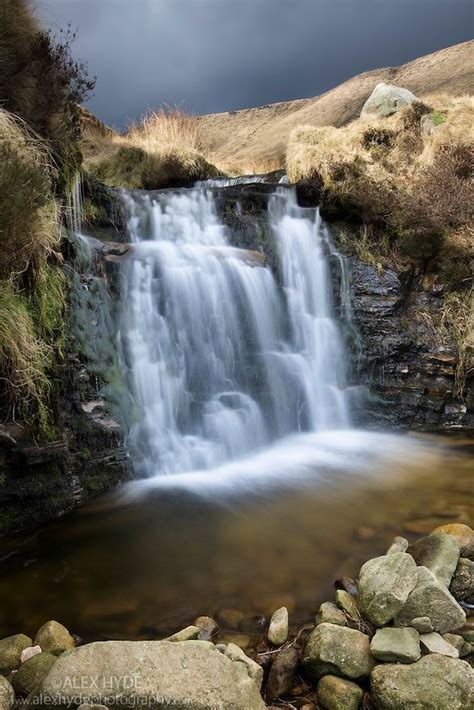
[0,234,130,536]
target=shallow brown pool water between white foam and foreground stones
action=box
[0,437,474,640]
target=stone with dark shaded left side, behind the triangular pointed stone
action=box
[408,533,459,587]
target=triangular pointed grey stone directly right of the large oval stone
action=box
[394,567,466,633]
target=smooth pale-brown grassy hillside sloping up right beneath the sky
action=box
[199,42,474,173]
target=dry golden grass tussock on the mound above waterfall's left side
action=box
[83,108,218,190]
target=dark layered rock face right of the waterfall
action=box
[352,260,474,432]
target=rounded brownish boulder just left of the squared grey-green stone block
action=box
[302,623,374,680]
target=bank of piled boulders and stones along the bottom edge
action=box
[0,524,474,710]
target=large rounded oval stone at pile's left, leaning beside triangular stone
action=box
[358,552,417,626]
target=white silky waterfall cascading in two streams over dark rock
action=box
[119,187,349,477]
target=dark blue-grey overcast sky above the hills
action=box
[33,0,473,128]
